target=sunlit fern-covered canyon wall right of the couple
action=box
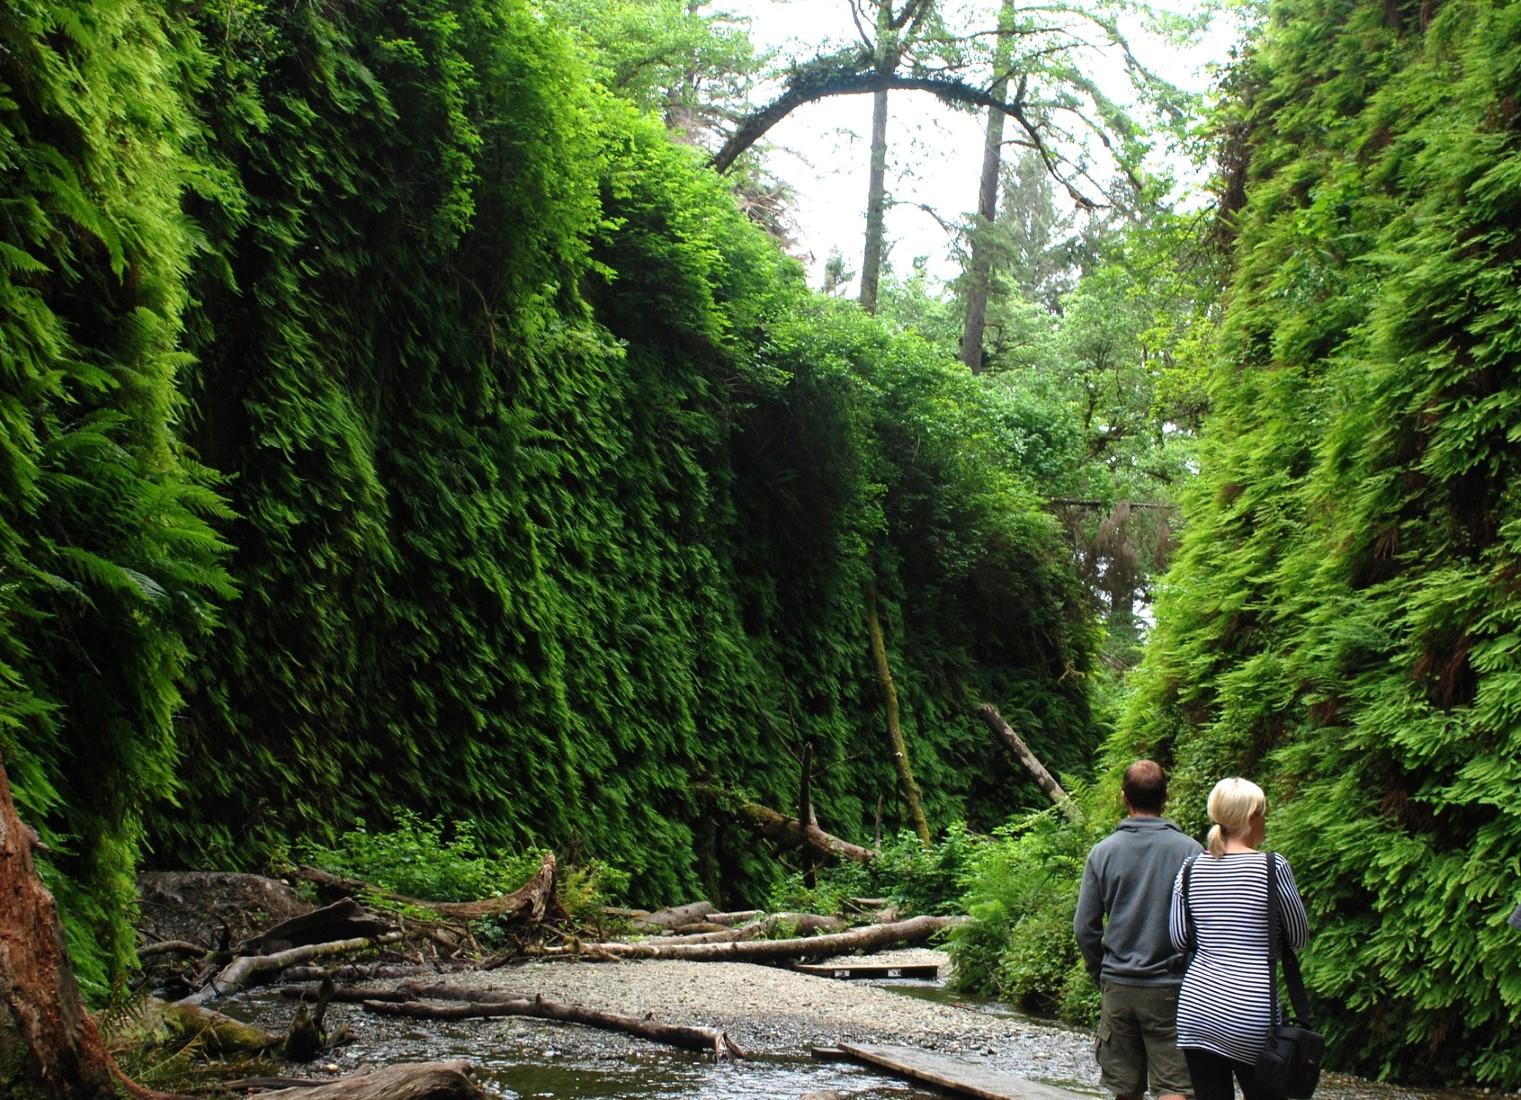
[1115,0,1521,1088]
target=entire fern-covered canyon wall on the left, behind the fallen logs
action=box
[0,0,1097,989]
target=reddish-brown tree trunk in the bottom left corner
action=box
[0,767,116,1100]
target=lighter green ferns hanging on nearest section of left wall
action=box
[0,0,228,993]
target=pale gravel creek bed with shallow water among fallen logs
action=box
[236,949,1521,1100]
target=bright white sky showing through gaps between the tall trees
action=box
[712,0,1230,286]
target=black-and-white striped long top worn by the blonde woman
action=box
[1168,852,1310,1063]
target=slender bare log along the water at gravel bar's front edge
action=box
[364,983,745,1059]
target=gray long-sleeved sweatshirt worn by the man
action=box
[1072,817,1203,986]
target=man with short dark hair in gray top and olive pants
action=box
[1072,761,1203,1100]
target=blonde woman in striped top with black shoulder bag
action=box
[1168,779,1308,1100]
